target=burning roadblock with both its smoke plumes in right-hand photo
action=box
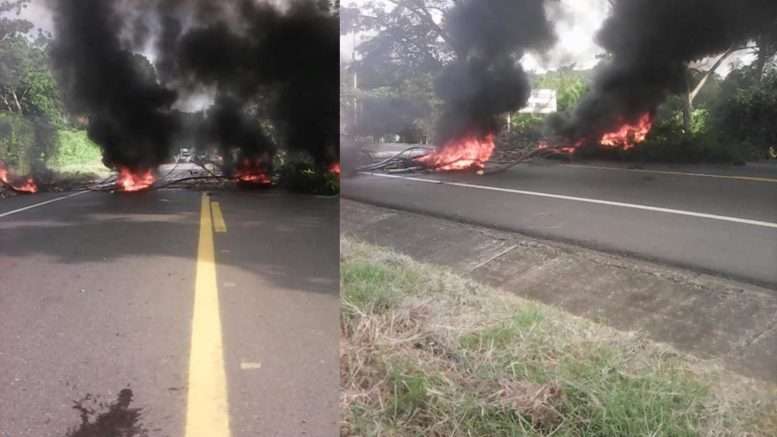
[360,0,777,173]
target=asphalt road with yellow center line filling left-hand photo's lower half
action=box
[0,186,339,437]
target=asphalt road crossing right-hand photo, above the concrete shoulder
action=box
[343,161,777,290]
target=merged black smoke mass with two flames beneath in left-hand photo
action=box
[48,0,339,191]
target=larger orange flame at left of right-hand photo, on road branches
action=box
[417,134,495,171]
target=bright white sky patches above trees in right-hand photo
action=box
[340,0,752,76]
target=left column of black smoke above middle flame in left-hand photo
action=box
[50,0,177,169]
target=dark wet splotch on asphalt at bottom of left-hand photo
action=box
[64,388,149,437]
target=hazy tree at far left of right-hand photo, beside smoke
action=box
[340,0,455,142]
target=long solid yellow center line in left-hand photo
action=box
[185,194,231,437]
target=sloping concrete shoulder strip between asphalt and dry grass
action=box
[341,200,777,382]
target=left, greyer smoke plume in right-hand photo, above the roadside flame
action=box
[435,0,555,143]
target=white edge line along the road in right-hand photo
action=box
[362,172,777,229]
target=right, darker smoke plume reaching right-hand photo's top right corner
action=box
[551,0,777,139]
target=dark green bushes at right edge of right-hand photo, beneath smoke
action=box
[572,63,777,164]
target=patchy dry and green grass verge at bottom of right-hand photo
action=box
[340,238,777,437]
